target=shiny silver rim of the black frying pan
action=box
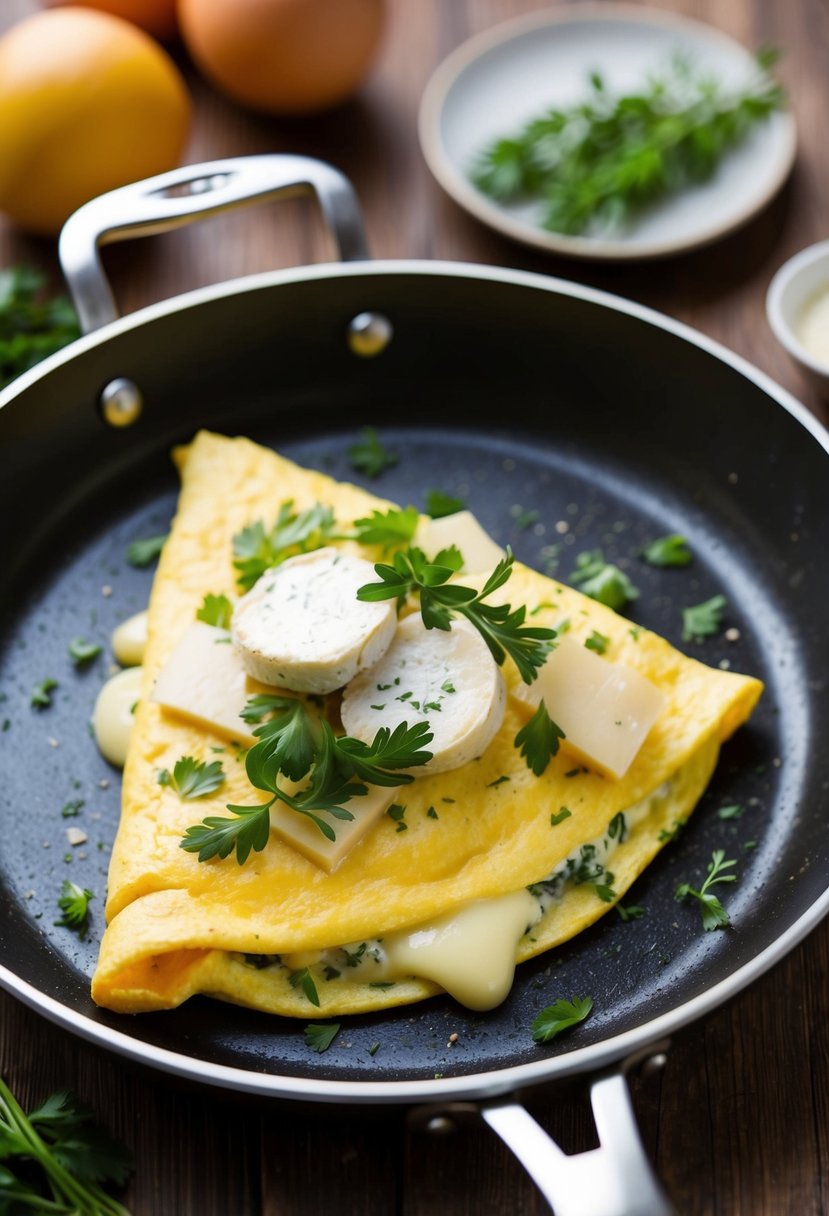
[0,259,829,1105]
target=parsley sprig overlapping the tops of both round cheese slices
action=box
[357,546,556,683]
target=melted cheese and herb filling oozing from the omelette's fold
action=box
[282,782,671,1012]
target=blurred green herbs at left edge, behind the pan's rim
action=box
[0,266,80,388]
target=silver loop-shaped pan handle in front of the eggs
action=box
[58,153,368,333]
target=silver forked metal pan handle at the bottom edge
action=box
[480,1071,675,1216]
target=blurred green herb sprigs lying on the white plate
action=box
[470,50,784,235]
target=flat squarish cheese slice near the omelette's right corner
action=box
[512,637,665,777]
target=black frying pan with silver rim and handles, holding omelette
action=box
[0,157,829,1216]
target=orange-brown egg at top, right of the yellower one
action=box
[179,0,385,113]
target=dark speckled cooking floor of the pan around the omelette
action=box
[0,406,811,1081]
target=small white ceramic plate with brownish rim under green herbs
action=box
[419,4,796,260]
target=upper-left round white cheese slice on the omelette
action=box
[231,546,397,693]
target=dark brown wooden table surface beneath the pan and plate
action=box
[0,0,829,1216]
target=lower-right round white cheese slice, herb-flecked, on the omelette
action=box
[340,613,506,776]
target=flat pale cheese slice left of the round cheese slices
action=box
[150,620,256,747]
